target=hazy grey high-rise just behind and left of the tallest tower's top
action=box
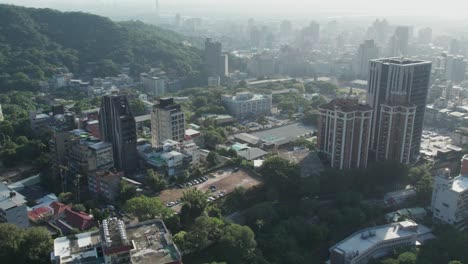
[354,40,379,80]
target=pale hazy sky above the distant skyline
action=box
[0,0,468,19]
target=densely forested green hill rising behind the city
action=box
[0,5,201,91]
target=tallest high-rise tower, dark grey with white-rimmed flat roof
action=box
[367,58,431,163]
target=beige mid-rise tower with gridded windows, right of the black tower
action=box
[151,98,185,147]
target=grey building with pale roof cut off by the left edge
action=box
[0,183,29,228]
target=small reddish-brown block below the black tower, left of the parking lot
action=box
[88,170,123,201]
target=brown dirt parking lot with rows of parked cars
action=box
[158,168,262,212]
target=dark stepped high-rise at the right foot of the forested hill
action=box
[203,38,229,77]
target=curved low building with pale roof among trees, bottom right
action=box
[330,220,434,264]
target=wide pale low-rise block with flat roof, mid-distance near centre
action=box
[222,92,272,119]
